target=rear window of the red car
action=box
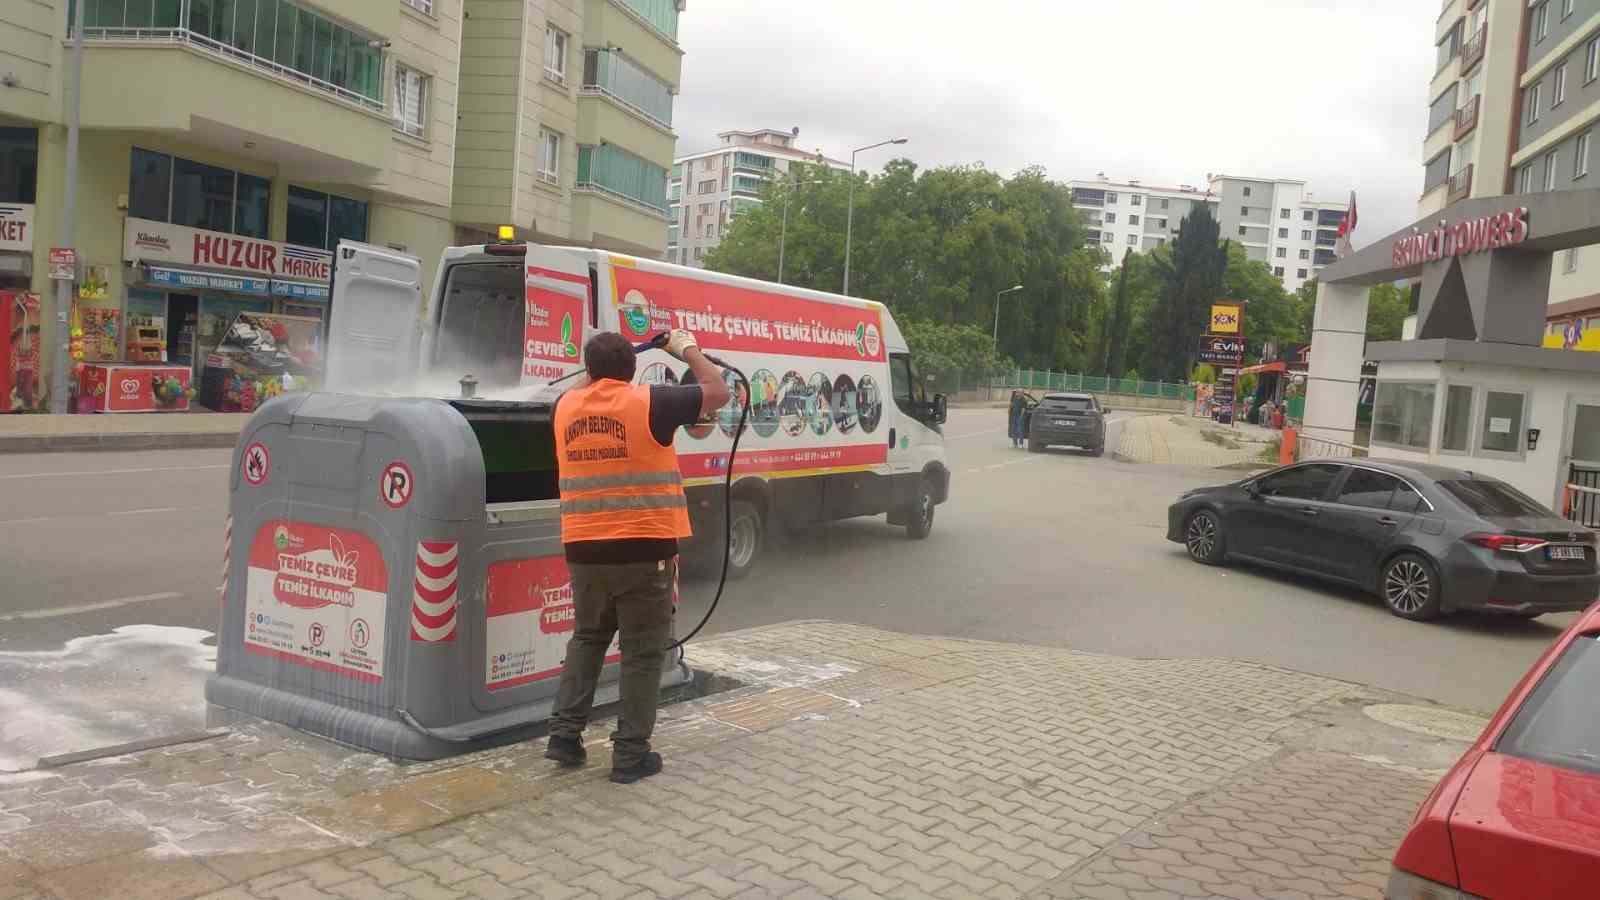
[1491,634,1600,778]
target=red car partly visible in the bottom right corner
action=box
[1386,604,1600,900]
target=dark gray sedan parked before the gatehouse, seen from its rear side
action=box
[1166,460,1600,620]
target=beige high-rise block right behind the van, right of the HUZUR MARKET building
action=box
[453,0,683,258]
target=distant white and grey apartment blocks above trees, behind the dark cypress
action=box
[1070,173,1349,291]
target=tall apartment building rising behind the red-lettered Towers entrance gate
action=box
[1418,0,1600,333]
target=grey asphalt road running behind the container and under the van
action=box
[0,410,1570,755]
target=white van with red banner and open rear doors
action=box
[326,242,950,577]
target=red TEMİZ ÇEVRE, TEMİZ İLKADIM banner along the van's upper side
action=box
[611,264,886,362]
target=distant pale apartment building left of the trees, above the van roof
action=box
[667,128,850,267]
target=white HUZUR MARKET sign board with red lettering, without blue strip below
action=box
[122,216,333,282]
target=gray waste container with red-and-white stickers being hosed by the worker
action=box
[205,394,690,759]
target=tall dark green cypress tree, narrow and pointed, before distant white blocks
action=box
[1141,203,1232,381]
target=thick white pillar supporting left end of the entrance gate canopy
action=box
[1302,283,1368,444]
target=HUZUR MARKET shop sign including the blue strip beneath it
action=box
[122,216,333,299]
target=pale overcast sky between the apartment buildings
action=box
[674,0,1438,245]
